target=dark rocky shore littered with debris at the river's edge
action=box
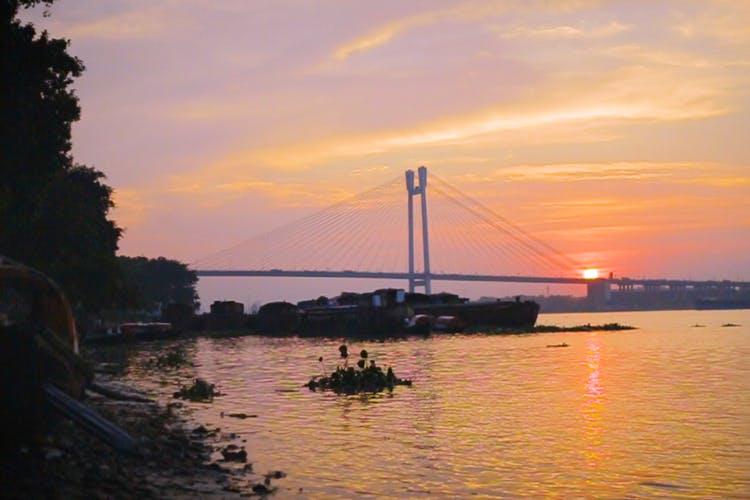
[0,374,283,499]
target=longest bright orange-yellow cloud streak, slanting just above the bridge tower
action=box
[153,63,727,201]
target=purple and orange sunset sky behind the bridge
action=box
[22,0,750,304]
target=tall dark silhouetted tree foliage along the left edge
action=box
[0,0,121,311]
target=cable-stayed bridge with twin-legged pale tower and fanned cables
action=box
[192,167,750,294]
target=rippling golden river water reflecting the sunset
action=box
[114,310,750,498]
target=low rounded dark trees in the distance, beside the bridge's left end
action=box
[118,257,200,309]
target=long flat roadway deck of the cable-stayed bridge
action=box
[196,269,750,290]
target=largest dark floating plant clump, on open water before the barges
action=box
[306,345,411,394]
